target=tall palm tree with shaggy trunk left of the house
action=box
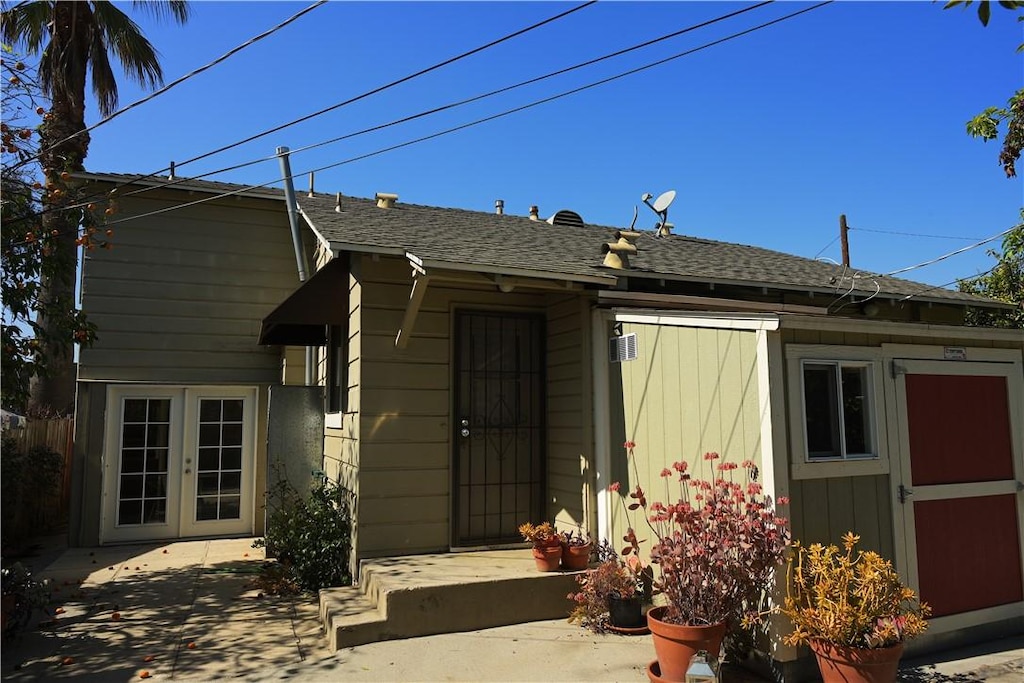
[0,0,188,414]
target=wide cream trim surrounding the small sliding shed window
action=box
[785,344,889,479]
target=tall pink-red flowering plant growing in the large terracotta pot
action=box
[609,441,790,626]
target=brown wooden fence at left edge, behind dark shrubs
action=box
[4,418,75,538]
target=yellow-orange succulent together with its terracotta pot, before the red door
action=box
[780,531,930,683]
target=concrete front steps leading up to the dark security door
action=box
[321,550,580,651]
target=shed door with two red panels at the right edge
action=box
[893,360,1024,631]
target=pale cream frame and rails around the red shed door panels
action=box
[883,344,1024,633]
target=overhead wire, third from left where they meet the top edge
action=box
[101,0,774,208]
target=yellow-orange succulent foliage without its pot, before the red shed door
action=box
[780,531,930,648]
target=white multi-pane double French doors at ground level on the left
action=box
[101,387,256,543]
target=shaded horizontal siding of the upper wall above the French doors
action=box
[80,190,299,384]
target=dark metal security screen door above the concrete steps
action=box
[452,311,545,547]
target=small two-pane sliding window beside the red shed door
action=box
[801,360,878,462]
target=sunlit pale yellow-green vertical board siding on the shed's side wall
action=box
[610,324,761,551]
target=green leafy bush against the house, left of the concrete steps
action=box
[253,476,352,591]
